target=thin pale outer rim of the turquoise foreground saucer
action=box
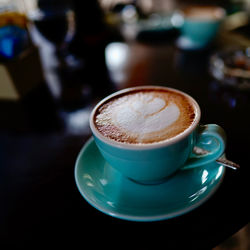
[74,136,226,222]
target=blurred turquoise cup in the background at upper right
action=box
[181,6,225,47]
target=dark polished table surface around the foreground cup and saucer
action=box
[0,30,250,249]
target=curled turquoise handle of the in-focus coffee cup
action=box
[181,124,226,170]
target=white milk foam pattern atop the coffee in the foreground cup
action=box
[111,94,180,137]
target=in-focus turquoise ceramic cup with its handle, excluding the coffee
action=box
[90,86,226,184]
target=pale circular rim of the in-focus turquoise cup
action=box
[89,85,201,150]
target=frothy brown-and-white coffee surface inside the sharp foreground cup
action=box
[94,88,196,144]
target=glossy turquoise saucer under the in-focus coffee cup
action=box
[75,138,225,221]
